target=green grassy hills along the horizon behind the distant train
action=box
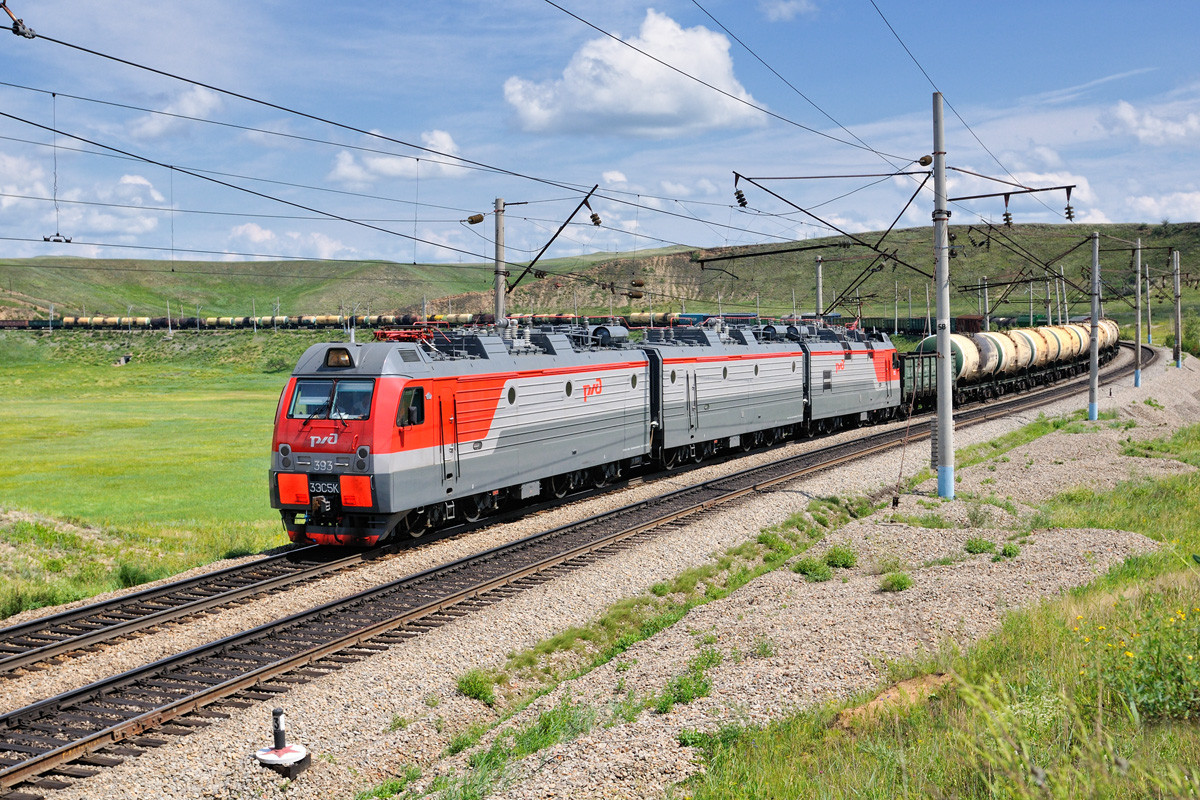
[0,222,1200,320]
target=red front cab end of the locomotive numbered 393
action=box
[270,344,397,546]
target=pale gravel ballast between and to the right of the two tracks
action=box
[11,345,1200,800]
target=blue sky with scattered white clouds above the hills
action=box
[0,0,1200,277]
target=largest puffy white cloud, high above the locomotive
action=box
[504,8,764,138]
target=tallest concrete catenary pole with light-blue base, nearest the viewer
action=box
[934,92,954,500]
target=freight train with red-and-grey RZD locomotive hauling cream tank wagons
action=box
[269,320,1117,546]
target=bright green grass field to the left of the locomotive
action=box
[0,331,341,615]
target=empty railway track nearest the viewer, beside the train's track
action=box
[0,340,1152,800]
